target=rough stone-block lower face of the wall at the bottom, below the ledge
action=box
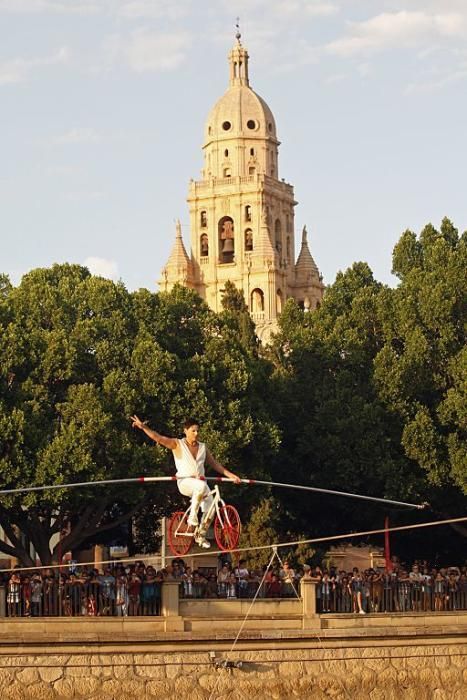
[0,640,467,700]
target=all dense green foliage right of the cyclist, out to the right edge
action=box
[270,220,467,556]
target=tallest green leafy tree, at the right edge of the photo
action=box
[375,219,467,494]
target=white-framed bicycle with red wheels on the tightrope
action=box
[168,484,242,557]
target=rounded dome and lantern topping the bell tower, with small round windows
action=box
[205,41,277,146]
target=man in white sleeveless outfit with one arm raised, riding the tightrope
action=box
[131,415,241,549]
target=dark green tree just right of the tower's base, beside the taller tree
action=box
[270,263,423,536]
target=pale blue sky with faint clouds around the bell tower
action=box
[0,0,467,289]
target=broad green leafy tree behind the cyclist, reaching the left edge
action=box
[0,265,277,565]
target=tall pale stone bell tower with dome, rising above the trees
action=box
[160,33,324,341]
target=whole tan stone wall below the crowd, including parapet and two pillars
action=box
[0,582,467,700]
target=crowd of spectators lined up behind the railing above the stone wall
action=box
[0,559,467,617]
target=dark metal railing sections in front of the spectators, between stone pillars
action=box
[0,575,467,618]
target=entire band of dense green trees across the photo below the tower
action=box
[0,220,467,565]
